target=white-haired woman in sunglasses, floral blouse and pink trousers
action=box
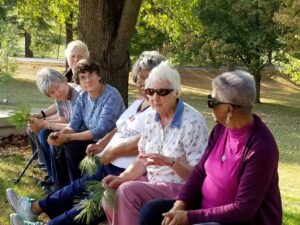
[103,62,208,225]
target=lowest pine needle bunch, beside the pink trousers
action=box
[75,181,115,224]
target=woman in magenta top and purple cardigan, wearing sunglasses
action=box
[140,71,282,225]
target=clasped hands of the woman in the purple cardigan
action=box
[162,209,189,225]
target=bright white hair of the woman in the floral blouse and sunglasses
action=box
[145,61,181,95]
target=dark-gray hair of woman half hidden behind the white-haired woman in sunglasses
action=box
[132,51,166,83]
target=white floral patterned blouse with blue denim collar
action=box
[138,100,208,184]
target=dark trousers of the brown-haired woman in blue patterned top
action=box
[64,141,95,182]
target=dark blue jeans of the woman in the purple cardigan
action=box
[139,199,225,225]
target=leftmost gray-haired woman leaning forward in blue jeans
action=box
[28,68,81,192]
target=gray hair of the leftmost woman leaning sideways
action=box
[36,67,67,96]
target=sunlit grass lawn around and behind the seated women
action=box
[0,66,300,225]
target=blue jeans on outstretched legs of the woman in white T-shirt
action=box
[38,164,124,225]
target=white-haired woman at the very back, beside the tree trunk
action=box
[64,40,90,82]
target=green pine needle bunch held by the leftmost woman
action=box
[9,105,31,128]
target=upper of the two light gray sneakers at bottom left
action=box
[6,188,37,222]
